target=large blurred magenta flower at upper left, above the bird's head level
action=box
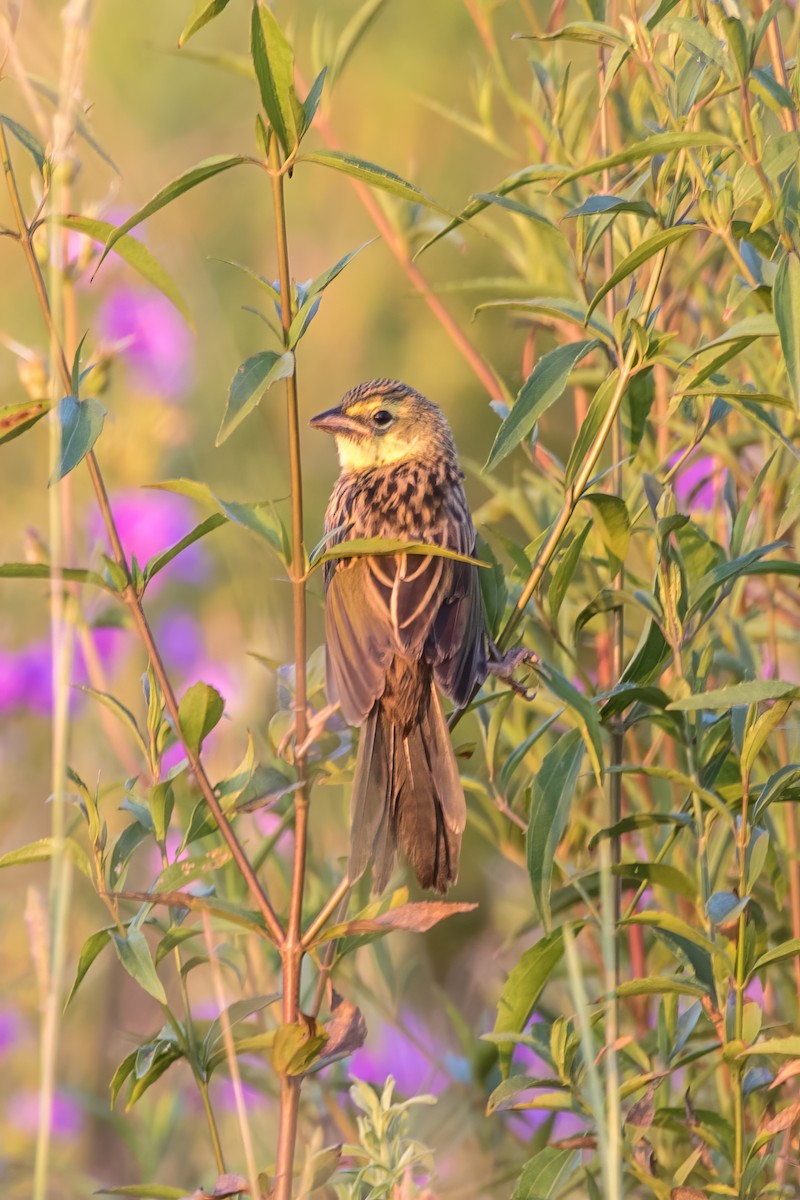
[98,287,192,397]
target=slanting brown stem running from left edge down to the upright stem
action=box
[0,126,283,946]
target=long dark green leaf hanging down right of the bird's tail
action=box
[527,730,584,931]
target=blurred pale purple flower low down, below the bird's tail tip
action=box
[349,1008,449,1096]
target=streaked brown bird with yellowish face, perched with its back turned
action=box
[311,379,492,894]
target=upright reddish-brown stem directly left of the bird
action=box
[270,134,308,1200]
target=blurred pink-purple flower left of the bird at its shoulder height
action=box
[90,491,209,580]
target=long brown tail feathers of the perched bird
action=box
[349,682,467,893]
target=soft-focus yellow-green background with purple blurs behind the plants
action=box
[0,0,570,1198]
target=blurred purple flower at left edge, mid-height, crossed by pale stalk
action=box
[0,628,125,716]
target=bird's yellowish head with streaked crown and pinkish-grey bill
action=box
[311,379,455,470]
